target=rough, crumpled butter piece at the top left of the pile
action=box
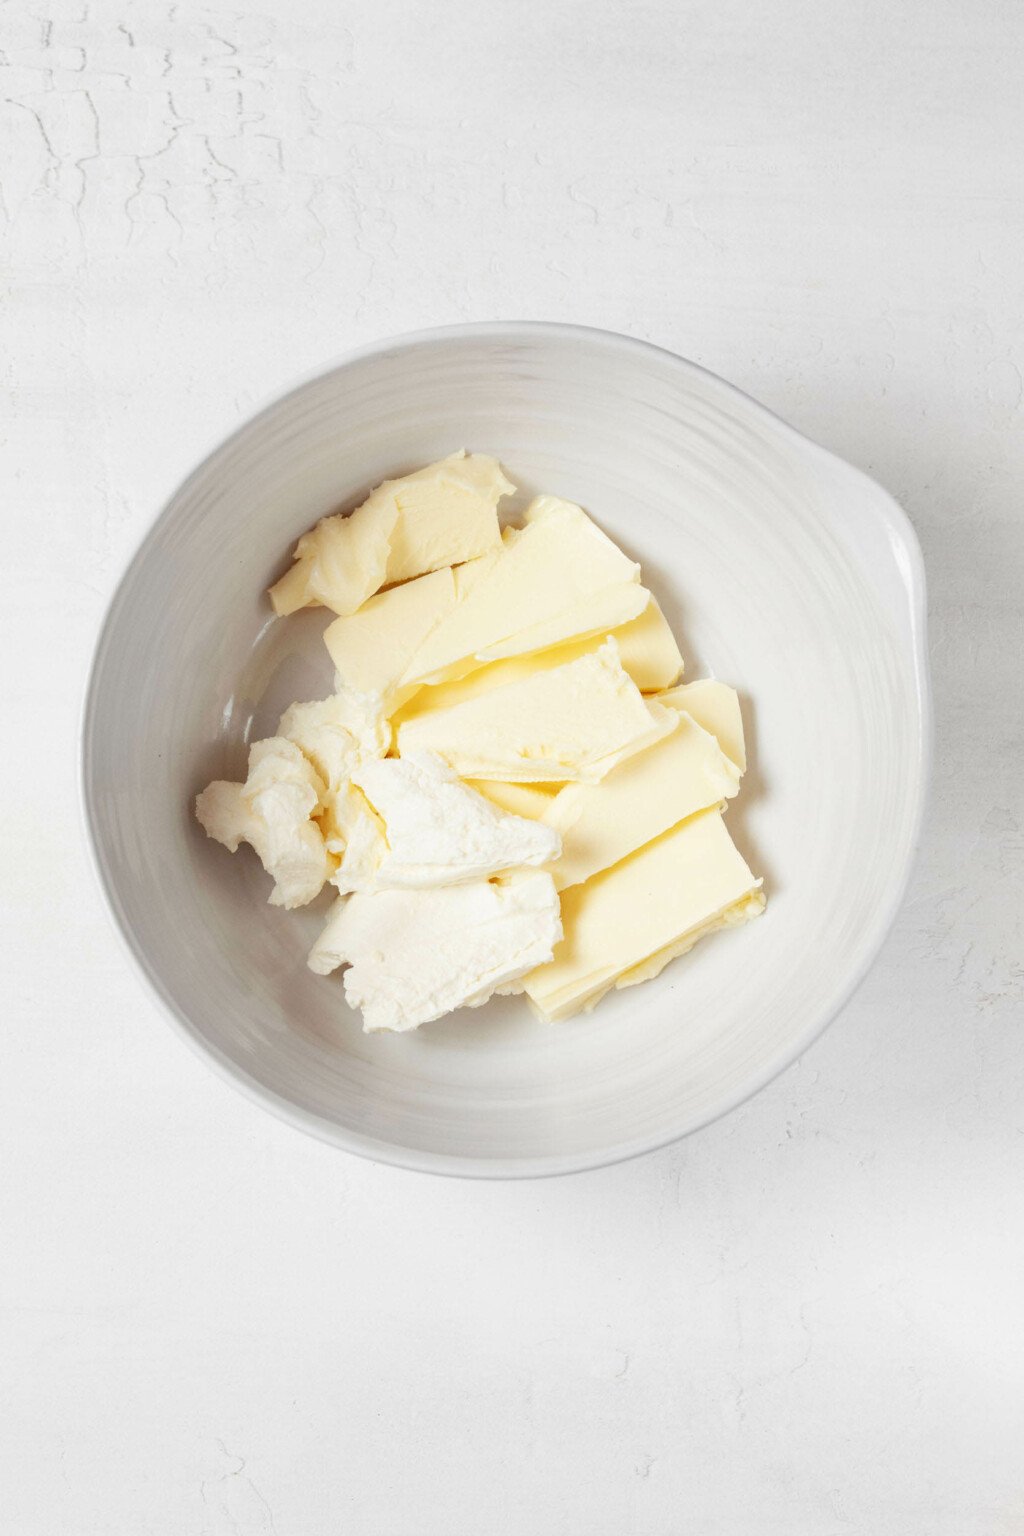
[270,452,514,614]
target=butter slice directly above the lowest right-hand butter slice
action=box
[543,714,740,891]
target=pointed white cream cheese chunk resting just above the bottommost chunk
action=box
[335,753,560,891]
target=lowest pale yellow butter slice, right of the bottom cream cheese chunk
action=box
[524,808,765,1021]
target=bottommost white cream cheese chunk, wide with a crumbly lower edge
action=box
[309,869,562,1032]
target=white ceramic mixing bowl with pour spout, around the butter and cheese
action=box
[83,324,930,1177]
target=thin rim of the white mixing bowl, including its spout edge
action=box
[77,319,933,1180]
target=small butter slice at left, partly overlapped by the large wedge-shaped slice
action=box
[324,567,456,696]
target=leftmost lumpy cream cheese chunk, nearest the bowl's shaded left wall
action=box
[195,736,335,908]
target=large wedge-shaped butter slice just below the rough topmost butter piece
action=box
[402,496,648,684]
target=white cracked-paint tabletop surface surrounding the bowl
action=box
[0,0,1024,1536]
